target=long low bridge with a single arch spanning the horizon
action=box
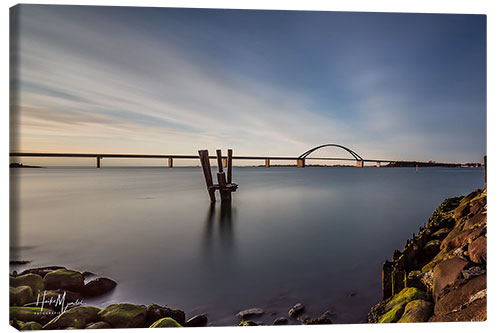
[9,143,468,168]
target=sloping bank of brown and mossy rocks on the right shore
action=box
[367,189,487,323]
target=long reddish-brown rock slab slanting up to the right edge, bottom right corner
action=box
[434,274,486,316]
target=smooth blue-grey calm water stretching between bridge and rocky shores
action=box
[11,167,483,325]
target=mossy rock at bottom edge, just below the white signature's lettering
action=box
[43,306,101,330]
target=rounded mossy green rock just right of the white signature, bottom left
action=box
[97,303,146,328]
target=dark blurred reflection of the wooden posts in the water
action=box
[204,201,234,254]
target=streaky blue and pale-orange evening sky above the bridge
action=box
[10,5,486,163]
